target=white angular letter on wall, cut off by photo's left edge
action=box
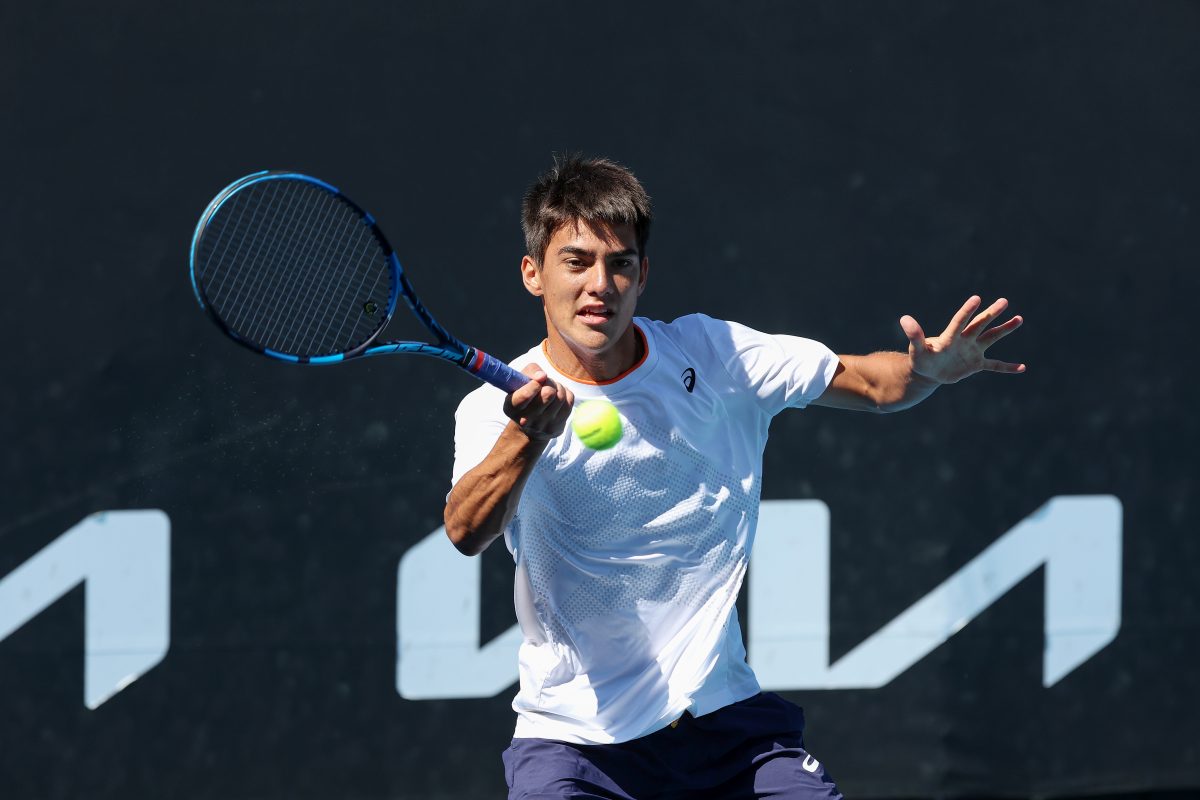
[0,510,170,709]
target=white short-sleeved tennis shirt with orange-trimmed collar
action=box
[452,314,838,744]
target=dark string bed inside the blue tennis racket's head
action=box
[197,179,392,356]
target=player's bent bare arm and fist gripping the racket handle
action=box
[444,365,575,555]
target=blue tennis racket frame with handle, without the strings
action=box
[188,170,529,392]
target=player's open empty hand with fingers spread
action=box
[900,295,1025,384]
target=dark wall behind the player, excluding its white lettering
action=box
[0,0,1200,798]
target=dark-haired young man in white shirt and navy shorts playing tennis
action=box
[445,158,1025,800]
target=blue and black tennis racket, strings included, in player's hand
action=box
[190,170,529,392]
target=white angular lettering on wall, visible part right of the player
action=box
[748,495,1122,690]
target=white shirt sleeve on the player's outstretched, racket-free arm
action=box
[703,317,839,416]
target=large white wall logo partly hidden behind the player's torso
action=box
[396,495,1122,699]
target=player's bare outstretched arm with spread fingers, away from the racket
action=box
[812,296,1025,413]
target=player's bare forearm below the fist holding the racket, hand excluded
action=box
[444,422,547,555]
